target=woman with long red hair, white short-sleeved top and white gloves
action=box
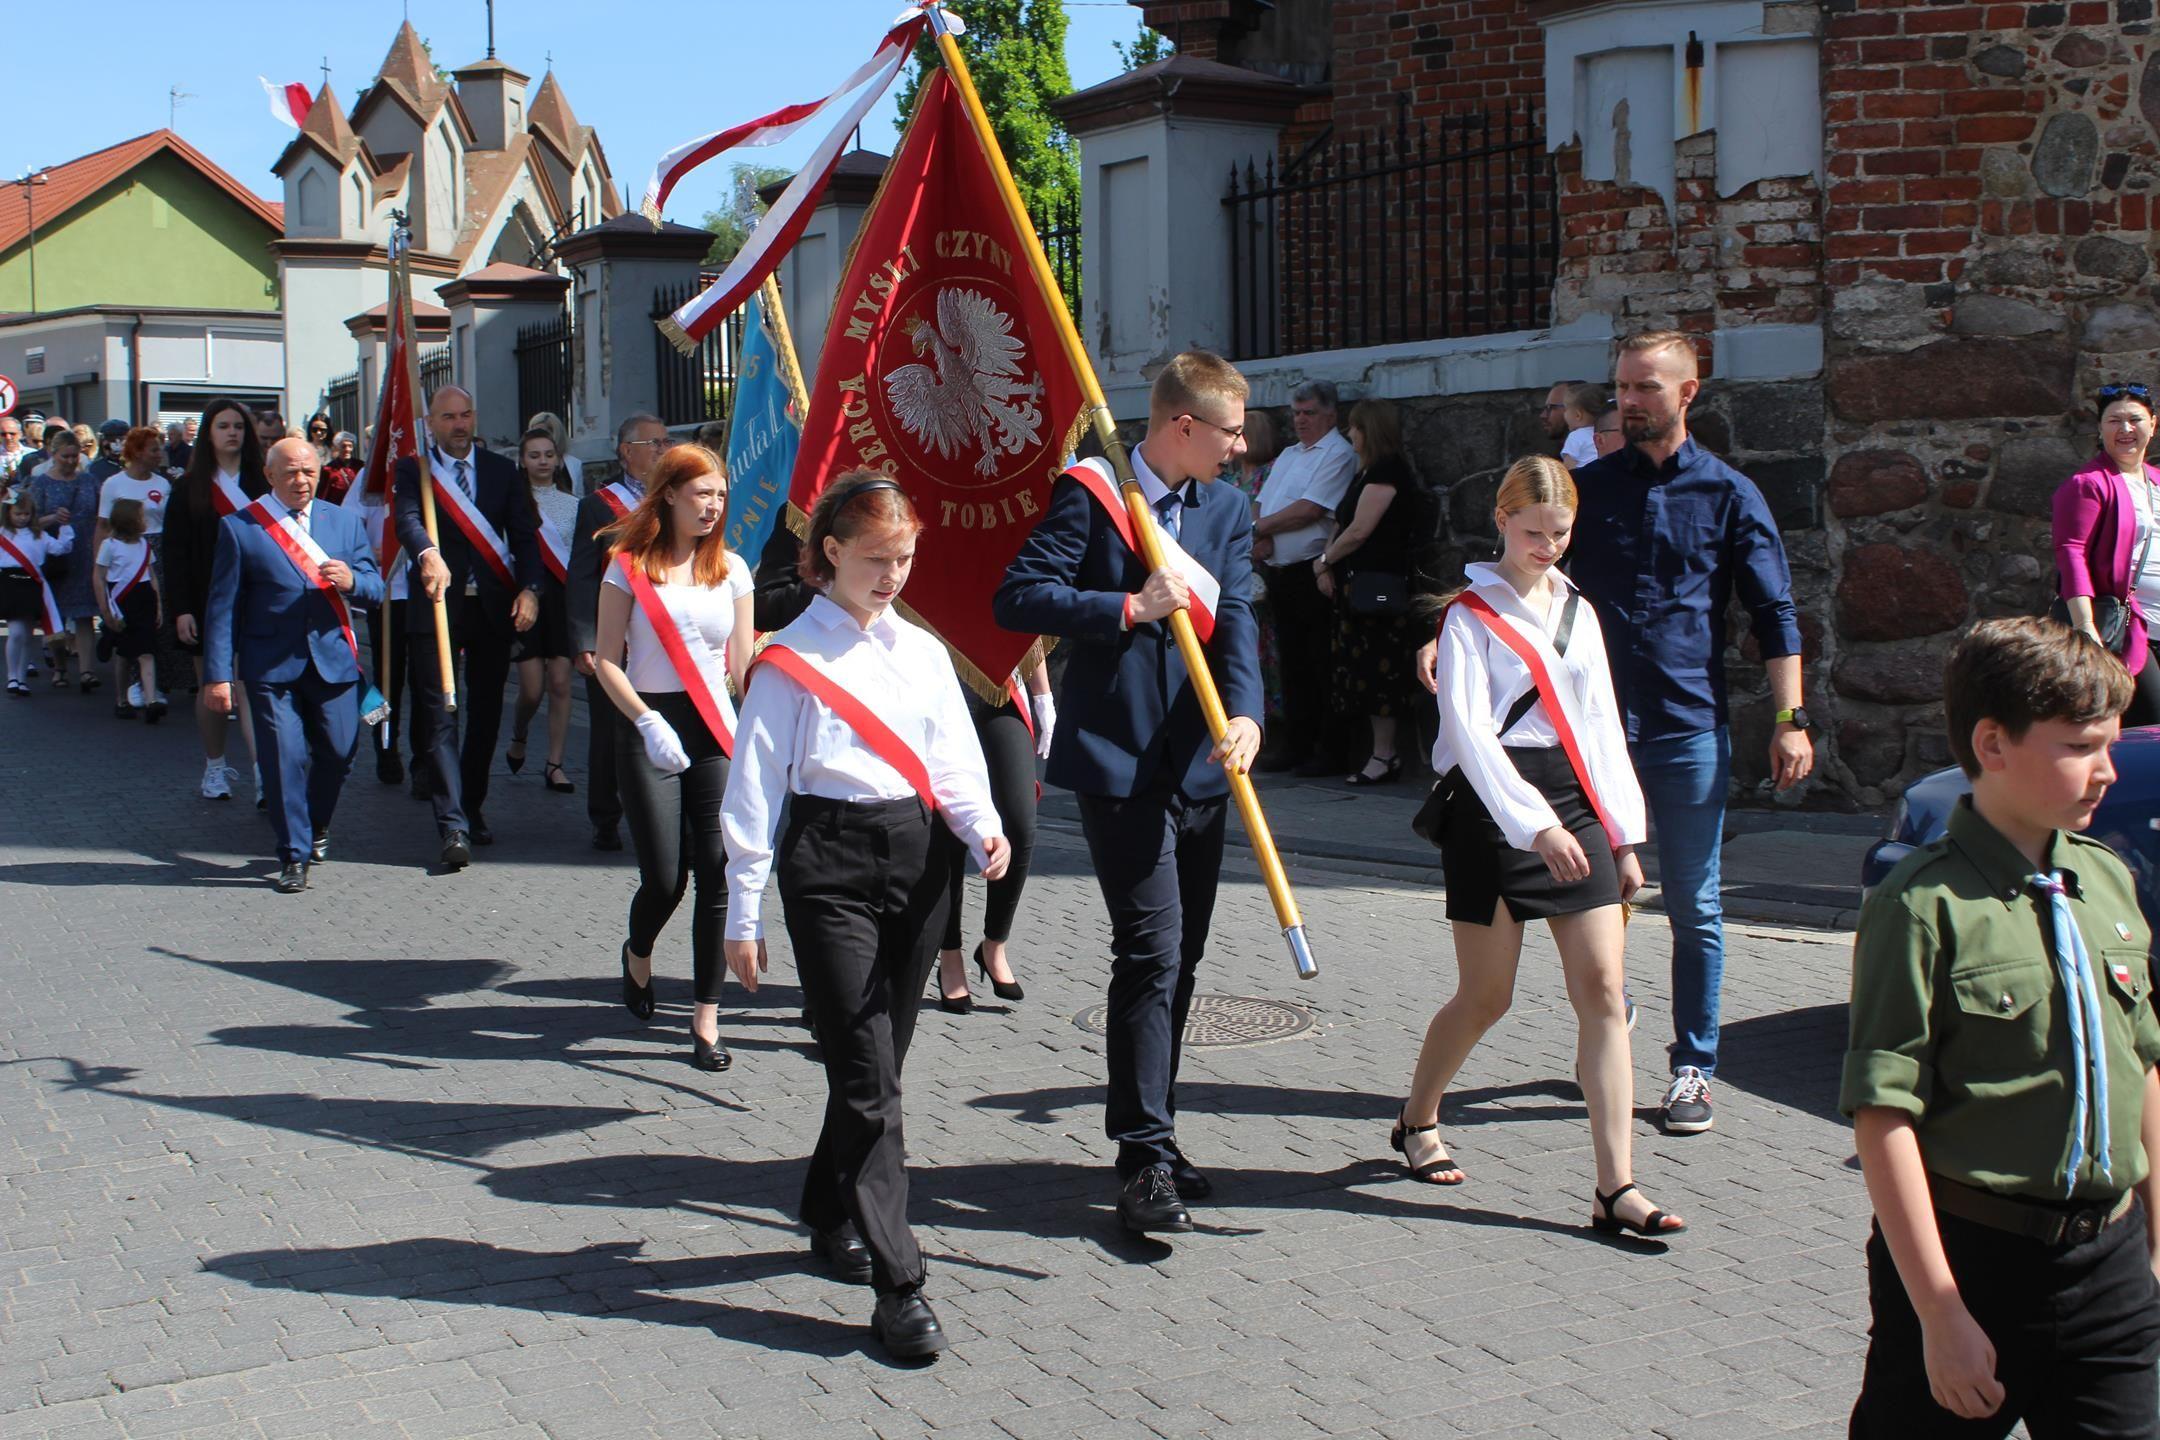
[592,445,754,1071]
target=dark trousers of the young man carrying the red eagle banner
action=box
[1080,784,1229,1179]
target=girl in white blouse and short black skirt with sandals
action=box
[1391,456,1685,1235]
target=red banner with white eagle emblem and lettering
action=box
[788,69,1082,697]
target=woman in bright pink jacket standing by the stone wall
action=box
[2054,384,2160,728]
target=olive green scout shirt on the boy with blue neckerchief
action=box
[1838,799,2160,1200]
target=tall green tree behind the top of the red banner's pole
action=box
[901,0,1080,216]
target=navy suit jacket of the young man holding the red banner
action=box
[991,477,1264,799]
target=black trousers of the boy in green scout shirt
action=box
[1847,1203,2160,1440]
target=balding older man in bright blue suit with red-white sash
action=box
[203,440,382,894]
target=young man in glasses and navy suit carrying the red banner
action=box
[994,352,1264,1235]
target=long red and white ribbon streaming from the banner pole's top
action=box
[644,4,937,343]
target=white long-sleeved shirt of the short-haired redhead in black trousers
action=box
[719,596,1004,939]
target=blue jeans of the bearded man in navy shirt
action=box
[1629,730,1732,1075]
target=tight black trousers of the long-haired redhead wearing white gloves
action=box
[607,691,728,1004]
